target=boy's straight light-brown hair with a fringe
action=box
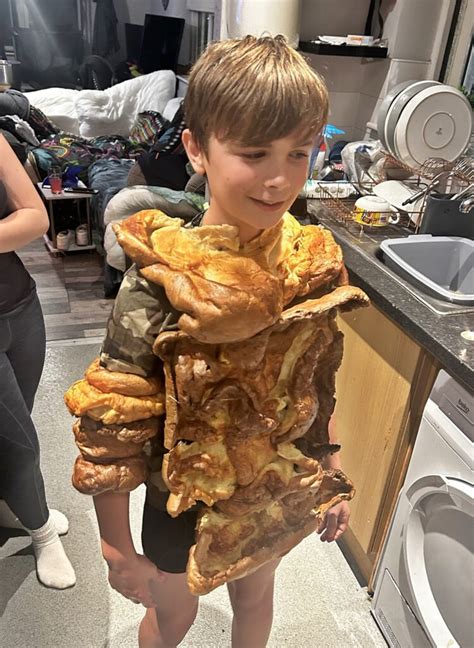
[184,36,328,153]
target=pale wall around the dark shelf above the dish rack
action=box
[301,0,454,139]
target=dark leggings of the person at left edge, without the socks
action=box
[0,294,48,529]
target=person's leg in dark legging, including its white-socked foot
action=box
[0,303,76,589]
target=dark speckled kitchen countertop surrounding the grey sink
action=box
[308,200,474,392]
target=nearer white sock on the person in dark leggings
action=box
[27,515,76,589]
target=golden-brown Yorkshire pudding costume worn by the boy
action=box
[65,210,368,594]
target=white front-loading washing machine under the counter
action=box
[372,371,474,648]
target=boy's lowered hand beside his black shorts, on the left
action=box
[109,554,165,608]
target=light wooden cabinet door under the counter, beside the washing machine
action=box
[336,306,434,579]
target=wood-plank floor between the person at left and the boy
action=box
[19,239,113,342]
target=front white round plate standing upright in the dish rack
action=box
[394,85,472,167]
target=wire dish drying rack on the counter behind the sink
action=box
[316,153,474,233]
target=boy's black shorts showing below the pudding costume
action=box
[142,499,198,574]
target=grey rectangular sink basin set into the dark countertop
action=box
[380,234,474,306]
